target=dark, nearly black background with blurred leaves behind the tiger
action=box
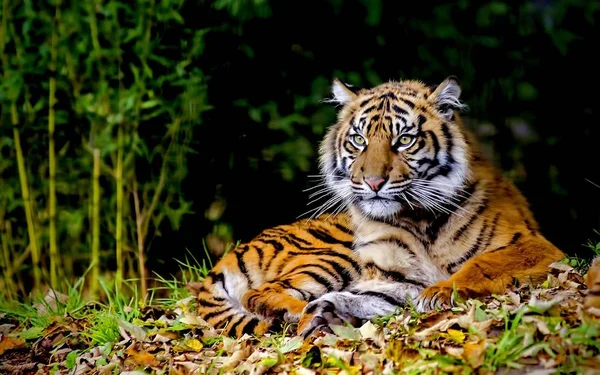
[150,1,600,274]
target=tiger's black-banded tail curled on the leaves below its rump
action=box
[188,270,273,338]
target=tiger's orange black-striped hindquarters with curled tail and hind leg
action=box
[194,214,360,337]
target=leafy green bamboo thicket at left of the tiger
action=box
[0,0,209,293]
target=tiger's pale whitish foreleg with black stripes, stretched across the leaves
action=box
[298,280,424,337]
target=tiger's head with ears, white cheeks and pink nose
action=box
[320,78,469,218]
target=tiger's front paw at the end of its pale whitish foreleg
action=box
[298,300,362,338]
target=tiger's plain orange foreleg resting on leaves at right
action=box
[416,236,565,311]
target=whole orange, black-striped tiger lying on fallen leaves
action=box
[193,77,565,337]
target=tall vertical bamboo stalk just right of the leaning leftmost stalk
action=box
[48,0,60,289]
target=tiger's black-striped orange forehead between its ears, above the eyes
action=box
[349,81,431,137]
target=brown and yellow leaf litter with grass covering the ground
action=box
[0,263,600,375]
